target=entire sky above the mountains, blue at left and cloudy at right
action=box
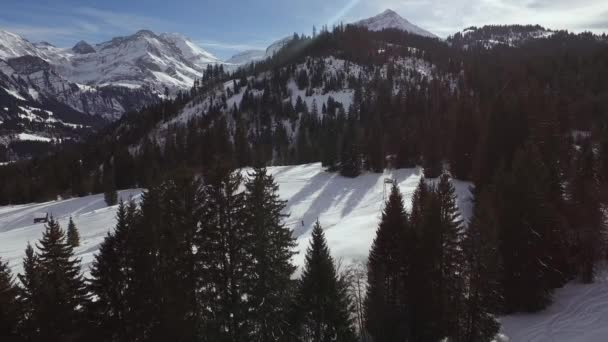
[0,0,608,58]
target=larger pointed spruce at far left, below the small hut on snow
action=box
[34,218,88,341]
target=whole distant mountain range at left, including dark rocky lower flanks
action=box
[0,30,223,159]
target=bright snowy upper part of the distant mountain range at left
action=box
[0,30,223,100]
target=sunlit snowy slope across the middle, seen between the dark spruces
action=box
[0,164,471,278]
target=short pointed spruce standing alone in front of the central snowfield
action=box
[295,222,356,342]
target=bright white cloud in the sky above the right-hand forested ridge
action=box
[342,0,608,37]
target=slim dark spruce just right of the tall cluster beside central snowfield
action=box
[461,191,502,342]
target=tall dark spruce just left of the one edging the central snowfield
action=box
[195,170,253,342]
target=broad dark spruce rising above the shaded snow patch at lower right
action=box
[495,143,563,312]
